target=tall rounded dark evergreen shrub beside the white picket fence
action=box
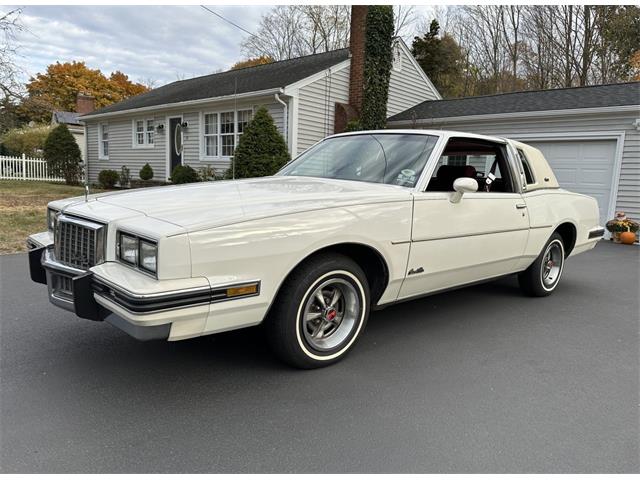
[43,124,82,185]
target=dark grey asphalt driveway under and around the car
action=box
[0,244,640,473]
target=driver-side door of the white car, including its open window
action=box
[400,139,529,298]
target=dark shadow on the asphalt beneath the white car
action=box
[52,277,526,381]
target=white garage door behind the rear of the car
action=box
[524,140,616,225]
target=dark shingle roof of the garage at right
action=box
[389,82,640,122]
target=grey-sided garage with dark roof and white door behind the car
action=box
[388,82,640,225]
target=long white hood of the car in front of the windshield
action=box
[58,176,410,231]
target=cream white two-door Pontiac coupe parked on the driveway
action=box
[28,130,604,368]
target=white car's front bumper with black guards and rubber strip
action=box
[28,242,268,341]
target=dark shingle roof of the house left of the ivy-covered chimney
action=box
[83,48,349,115]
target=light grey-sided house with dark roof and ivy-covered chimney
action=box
[81,33,441,182]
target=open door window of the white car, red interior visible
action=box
[427,138,514,193]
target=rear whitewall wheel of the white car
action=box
[518,233,565,297]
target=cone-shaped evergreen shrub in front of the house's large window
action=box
[225,107,291,178]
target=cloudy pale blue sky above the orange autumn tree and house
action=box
[5,5,270,85]
